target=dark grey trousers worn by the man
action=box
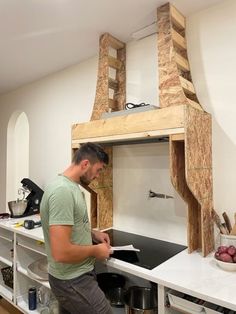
[49,271,113,314]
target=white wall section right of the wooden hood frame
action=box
[187,0,236,221]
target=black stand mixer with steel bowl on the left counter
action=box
[8,178,44,218]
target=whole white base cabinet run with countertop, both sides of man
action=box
[0,216,236,314]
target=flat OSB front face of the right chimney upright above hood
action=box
[157,3,188,108]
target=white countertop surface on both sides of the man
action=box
[0,215,236,311]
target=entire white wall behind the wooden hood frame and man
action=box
[0,0,236,243]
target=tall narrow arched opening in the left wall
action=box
[6,111,29,208]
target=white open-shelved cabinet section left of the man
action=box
[0,217,50,314]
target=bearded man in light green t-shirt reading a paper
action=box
[40,143,112,314]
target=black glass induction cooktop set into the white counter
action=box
[106,229,186,269]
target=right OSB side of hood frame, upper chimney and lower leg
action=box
[157,3,214,256]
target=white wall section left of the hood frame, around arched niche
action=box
[0,58,97,212]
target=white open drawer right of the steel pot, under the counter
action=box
[168,290,205,314]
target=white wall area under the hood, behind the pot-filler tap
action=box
[113,143,187,244]
